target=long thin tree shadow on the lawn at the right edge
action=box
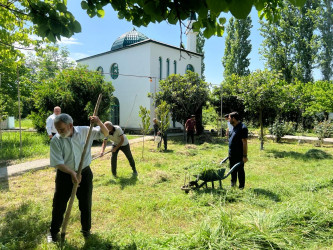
[267,149,332,160]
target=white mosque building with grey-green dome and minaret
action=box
[77,20,202,131]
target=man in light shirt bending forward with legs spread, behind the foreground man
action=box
[101,121,138,177]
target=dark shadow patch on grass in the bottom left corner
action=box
[0,201,50,249]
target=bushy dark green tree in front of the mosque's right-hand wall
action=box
[154,71,209,133]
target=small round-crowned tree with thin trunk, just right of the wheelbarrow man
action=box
[238,70,286,150]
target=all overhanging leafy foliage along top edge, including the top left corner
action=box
[0,0,305,42]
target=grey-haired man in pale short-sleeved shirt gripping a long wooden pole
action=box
[48,113,108,242]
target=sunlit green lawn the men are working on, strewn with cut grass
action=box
[0,138,333,249]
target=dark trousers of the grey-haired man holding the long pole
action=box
[50,166,93,235]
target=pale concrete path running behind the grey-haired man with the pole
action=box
[0,136,154,180]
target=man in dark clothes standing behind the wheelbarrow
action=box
[229,112,248,189]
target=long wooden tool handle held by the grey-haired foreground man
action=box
[61,94,102,243]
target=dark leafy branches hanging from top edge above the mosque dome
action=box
[81,0,305,38]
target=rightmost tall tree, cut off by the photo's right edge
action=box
[319,0,333,81]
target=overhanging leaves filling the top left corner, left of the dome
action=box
[0,0,81,42]
